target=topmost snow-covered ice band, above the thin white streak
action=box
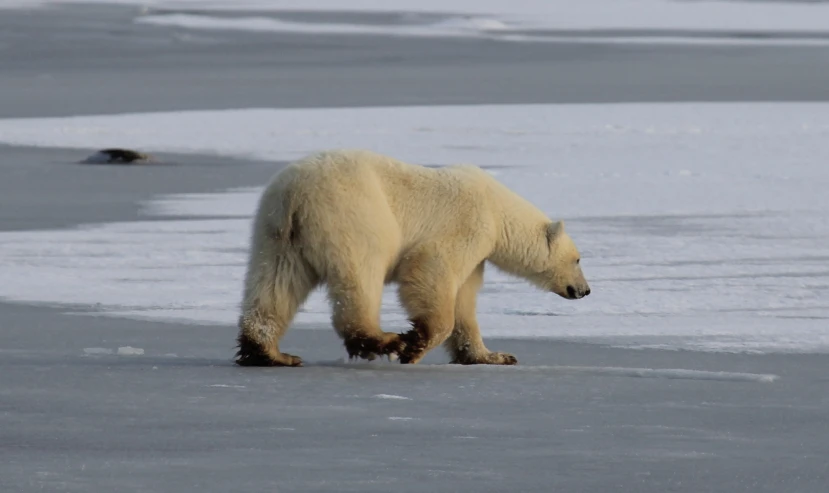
[6,0,829,31]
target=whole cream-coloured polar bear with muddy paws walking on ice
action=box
[236,149,590,366]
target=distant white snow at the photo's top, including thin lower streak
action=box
[0,0,829,44]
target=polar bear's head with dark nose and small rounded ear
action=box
[534,221,590,300]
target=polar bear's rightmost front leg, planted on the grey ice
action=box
[445,262,518,365]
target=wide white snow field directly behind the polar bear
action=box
[0,103,829,352]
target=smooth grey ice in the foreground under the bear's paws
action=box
[0,316,829,493]
